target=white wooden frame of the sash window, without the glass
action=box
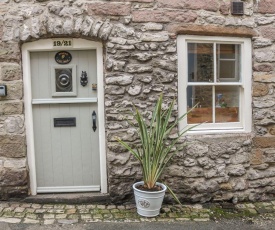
[177,35,252,134]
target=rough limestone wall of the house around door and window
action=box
[0,0,275,202]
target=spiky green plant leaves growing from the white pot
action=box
[117,94,196,192]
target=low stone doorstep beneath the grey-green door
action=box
[24,192,111,204]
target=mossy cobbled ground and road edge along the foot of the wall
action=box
[0,201,275,230]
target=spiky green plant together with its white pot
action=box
[117,94,196,217]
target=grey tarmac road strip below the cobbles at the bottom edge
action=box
[0,219,275,230]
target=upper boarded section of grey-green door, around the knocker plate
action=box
[31,50,97,99]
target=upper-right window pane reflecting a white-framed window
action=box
[217,44,240,82]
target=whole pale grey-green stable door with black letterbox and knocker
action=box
[30,50,100,193]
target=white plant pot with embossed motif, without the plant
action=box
[133,181,167,217]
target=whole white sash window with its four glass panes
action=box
[177,35,252,133]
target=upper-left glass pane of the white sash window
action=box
[188,43,214,82]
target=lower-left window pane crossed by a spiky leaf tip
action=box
[187,86,213,124]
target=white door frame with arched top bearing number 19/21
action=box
[22,38,107,195]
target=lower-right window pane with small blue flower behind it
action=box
[215,86,240,123]
